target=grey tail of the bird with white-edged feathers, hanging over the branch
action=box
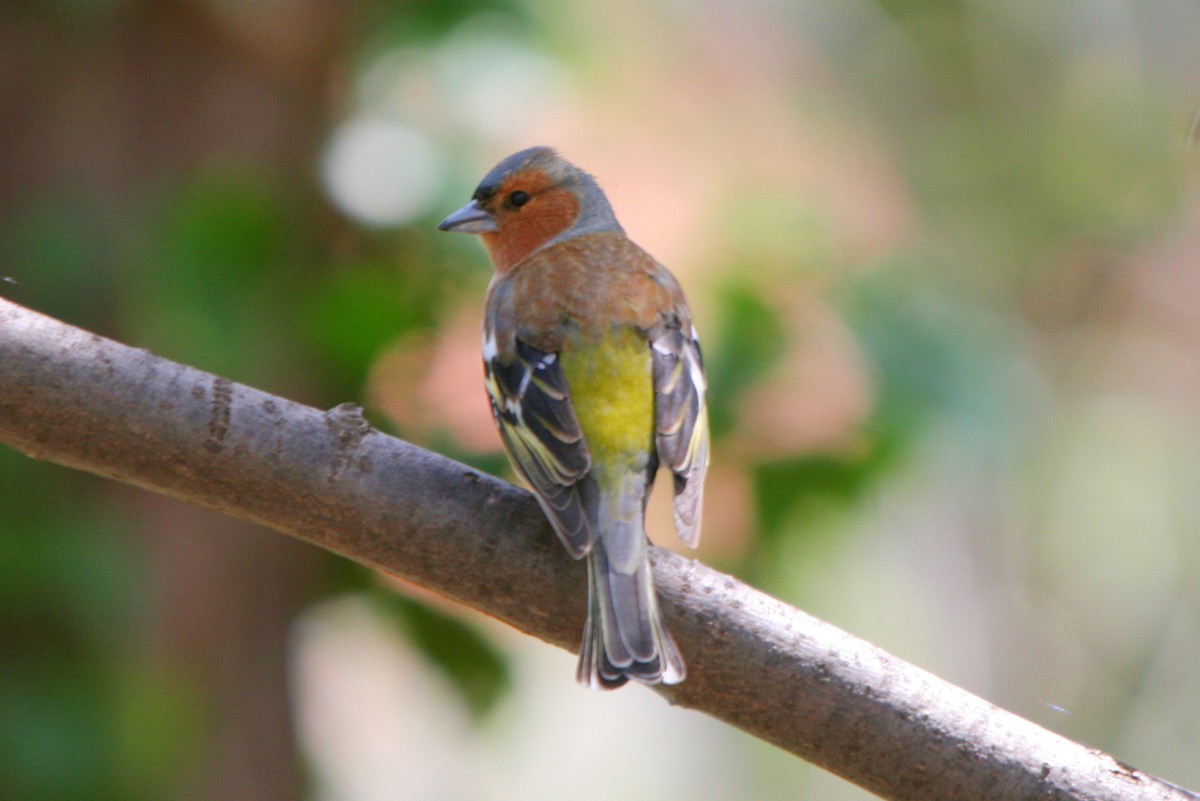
[577,520,686,689]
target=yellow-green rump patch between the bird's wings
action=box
[559,327,654,465]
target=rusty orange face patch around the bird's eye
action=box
[480,168,580,273]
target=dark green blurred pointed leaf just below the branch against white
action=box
[372,590,511,718]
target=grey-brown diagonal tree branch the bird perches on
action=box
[0,299,1200,801]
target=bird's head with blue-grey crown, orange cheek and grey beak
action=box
[438,147,622,272]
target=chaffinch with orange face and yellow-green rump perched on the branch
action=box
[438,146,709,689]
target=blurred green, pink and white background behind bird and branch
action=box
[0,0,1200,801]
